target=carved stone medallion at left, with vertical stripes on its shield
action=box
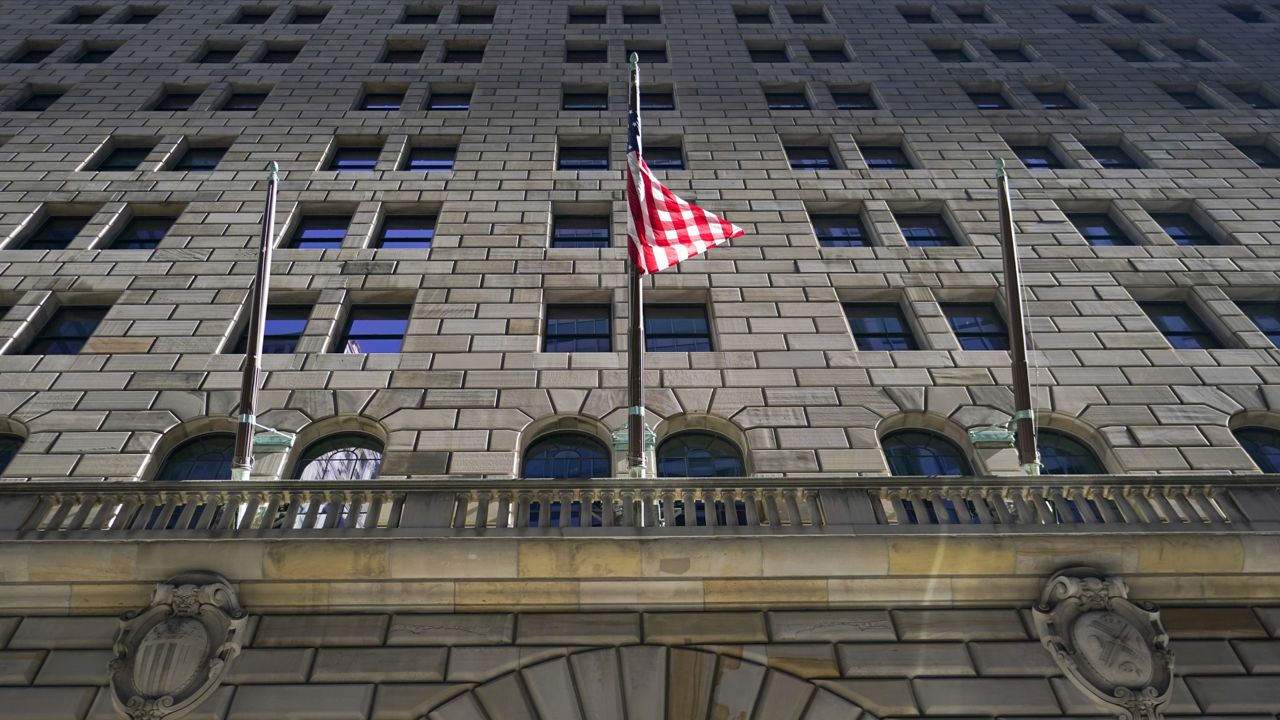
[111,573,248,720]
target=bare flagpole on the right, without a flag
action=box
[996,160,1041,475]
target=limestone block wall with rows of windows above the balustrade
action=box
[0,0,1280,479]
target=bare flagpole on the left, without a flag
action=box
[232,161,280,480]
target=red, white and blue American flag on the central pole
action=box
[627,72,745,274]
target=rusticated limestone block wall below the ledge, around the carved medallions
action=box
[0,606,1280,720]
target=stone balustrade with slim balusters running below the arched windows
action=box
[0,475,1280,539]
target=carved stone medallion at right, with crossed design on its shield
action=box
[1033,568,1174,720]
